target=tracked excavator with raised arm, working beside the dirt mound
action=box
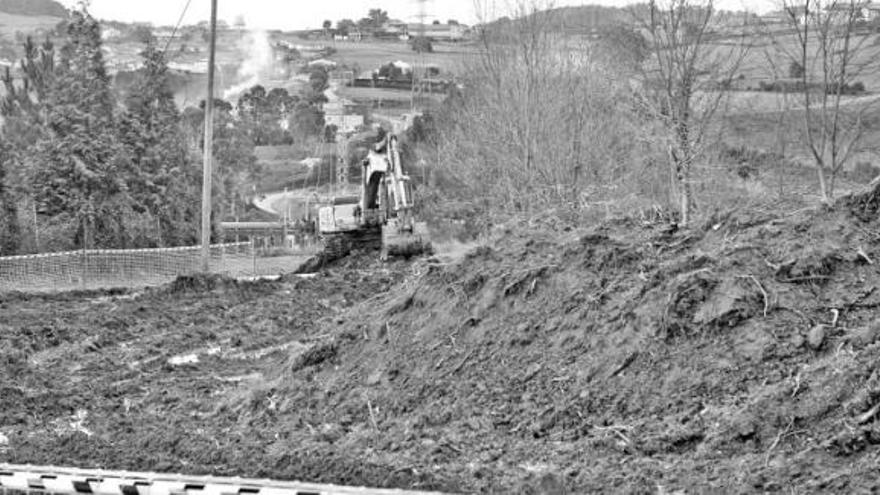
[318,133,431,260]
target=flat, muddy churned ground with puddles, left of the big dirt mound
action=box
[0,266,460,488]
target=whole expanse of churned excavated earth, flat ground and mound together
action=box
[0,189,880,493]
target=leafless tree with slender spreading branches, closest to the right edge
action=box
[772,0,878,203]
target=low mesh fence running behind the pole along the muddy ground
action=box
[0,242,313,292]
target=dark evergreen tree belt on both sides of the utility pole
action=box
[0,6,328,255]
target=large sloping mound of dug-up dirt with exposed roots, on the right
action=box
[234,203,880,492]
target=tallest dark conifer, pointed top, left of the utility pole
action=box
[34,10,131,252]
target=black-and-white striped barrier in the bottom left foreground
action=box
[0,464,439,495]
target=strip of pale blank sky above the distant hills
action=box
[61,0,772,29]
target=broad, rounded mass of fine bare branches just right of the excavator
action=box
[427,1,658,220]
